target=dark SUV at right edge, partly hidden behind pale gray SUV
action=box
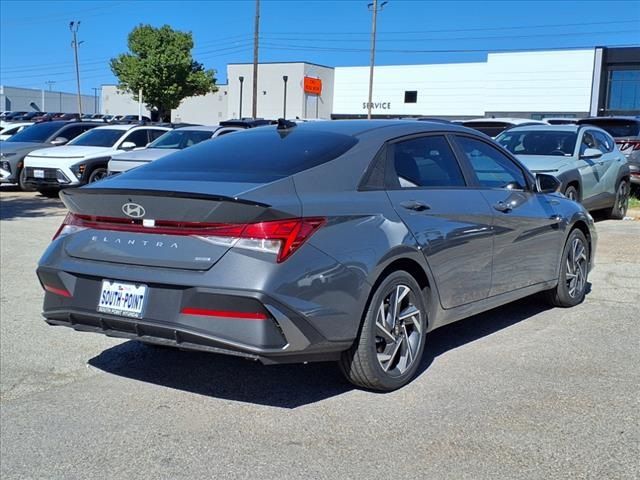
[578,117,640,189]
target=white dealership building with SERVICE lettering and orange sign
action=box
[100,47,640,124]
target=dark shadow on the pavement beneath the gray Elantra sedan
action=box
[89,290,576,409]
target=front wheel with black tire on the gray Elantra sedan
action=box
[547,228,591,307]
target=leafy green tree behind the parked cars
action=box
[110,25,218,121]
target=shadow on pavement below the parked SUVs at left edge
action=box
[0,186,66,220]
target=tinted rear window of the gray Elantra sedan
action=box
[125,127,358,183]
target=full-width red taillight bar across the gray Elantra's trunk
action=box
[53,213,326,263]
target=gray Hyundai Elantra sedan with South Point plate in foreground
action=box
[37,120,597,391]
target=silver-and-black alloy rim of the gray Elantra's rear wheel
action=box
[375,284,424,376]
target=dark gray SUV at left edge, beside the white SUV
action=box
[0,120,104,190]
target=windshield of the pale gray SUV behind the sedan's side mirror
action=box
[496,130,578,157]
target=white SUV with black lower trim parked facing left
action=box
[24,125,171,194]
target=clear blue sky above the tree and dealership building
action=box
[0,0,640,93]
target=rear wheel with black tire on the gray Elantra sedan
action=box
[339,270,428,391]
